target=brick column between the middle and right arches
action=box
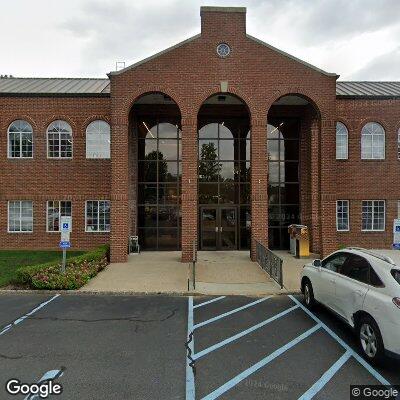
[250,116,268,261]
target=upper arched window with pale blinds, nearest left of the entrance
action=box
[86,120,110,158]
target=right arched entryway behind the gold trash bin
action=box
[267,94,320,250]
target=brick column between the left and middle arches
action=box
[182,118,198,262]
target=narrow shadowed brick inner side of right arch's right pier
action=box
[310,118,321,253]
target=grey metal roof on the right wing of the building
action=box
[336,81,400,99]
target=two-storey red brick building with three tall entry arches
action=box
[0,7,400,261]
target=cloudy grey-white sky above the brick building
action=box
[0,0,400,80]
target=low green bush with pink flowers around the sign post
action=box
[15,245,109,290]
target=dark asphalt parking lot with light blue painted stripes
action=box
[0,294,400,400]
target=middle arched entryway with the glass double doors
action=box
[198,93,251,250]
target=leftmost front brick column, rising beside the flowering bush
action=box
[111,116,129,262]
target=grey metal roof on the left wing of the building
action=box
[0,77,110,96]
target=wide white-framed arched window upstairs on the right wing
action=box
[361,122,385,160]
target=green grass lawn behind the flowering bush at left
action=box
[0,250,84,287]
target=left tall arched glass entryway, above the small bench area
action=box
[129,92,182,250]
